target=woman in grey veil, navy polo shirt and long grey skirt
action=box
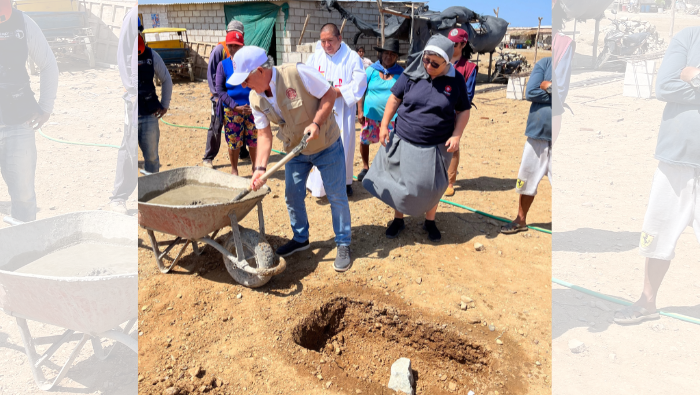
[362,35,471,241]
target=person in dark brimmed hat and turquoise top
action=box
[357,39,403,182]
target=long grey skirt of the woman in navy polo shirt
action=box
[362,133,452,216]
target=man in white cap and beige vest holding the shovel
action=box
[228,46,352,272]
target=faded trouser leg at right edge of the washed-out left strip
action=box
[110,100,139,202]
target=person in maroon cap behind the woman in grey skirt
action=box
[445,29,479,196]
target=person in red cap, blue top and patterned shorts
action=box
[216,30,258,175]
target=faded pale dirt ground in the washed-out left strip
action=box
[0,62,136,394]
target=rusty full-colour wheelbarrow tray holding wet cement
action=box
[138,167,270,240]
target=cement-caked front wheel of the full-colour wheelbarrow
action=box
[224,227,275,288]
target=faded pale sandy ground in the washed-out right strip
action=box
[552,9,700,394]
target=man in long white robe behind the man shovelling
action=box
[306,23,367,197]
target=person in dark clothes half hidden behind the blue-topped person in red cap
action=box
[202,19,250,168]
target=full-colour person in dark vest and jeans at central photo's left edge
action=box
[138,17,173,173]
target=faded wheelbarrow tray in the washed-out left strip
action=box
[0,211,138,335]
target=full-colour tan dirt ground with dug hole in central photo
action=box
[139,65,551,395]
